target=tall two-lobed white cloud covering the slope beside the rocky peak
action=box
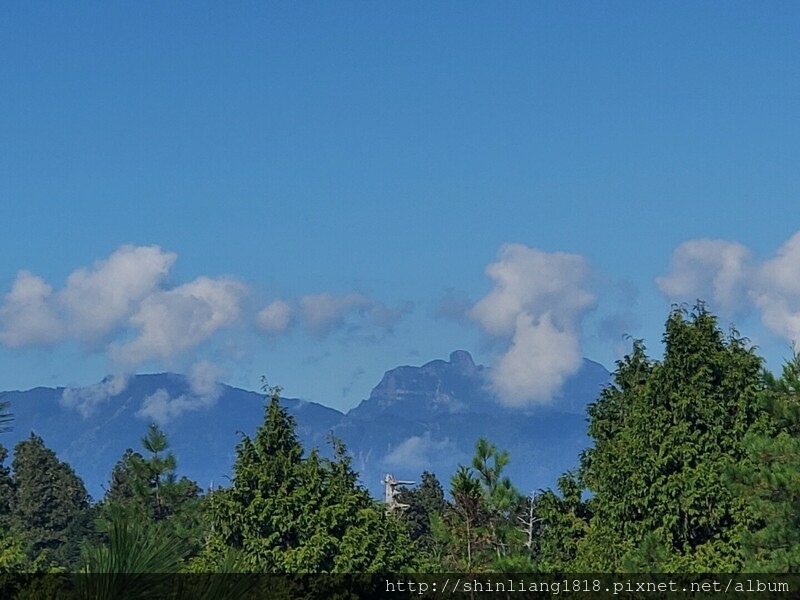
[469,244,596,406]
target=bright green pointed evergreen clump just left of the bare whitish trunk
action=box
[198,388,412,573]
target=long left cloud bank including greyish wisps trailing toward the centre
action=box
[0,245,411,394]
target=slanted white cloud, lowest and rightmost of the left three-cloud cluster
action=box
[111,277,247,365]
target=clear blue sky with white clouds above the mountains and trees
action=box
[0,2,800,408]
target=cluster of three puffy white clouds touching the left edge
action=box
[0,245,242,370]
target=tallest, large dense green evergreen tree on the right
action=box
[577,306,762,572]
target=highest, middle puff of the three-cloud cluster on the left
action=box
[59,245,177,341]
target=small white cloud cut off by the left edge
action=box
[0,271,64,348]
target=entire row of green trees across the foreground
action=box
[0,305,800,576]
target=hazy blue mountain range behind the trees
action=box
[0,351,609,498]
